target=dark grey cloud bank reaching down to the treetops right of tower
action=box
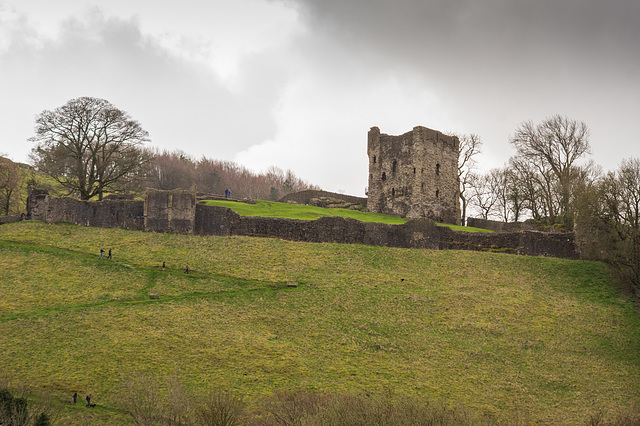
[289,0,640,172]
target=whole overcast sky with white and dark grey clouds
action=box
[0,0,640,195]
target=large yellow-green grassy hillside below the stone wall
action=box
[0,222,640,424]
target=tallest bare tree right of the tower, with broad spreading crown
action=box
[510,115,590,226]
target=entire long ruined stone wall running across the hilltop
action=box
[27,191,579,259]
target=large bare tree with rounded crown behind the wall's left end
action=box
[30,97,150,200]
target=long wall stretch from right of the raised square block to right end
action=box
[190,204,579,259]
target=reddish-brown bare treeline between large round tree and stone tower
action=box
[146,151,320,201]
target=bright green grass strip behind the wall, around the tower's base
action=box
[206,200,491,232]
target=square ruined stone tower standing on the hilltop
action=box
[367,126,460,224]
